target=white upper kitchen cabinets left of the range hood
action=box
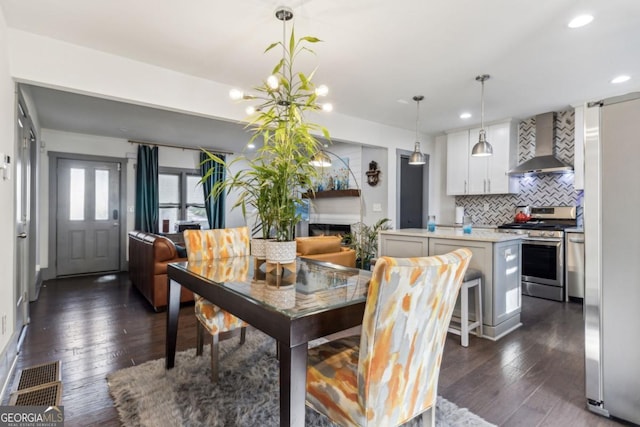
[447,121,519,196]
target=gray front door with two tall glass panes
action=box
[56,158,121,276]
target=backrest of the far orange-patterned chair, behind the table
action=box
[183,227,250,262]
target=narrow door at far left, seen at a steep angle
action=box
[15,101,35,331]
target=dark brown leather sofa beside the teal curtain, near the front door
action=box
[129,231,193,311]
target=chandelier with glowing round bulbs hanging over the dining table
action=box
[229,6,333,125]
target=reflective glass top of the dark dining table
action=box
[172,256,371,318]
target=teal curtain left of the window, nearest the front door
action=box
[135,145,159,233]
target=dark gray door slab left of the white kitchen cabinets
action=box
[400,156,426,228]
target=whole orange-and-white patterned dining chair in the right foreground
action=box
[307,248,471,427]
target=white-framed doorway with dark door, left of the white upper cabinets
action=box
[397,150,429,228]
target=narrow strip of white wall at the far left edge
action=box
[0,5,17,387]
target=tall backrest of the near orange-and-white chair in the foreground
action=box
[358,249,471,426]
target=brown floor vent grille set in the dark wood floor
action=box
[9,360,62,406]
